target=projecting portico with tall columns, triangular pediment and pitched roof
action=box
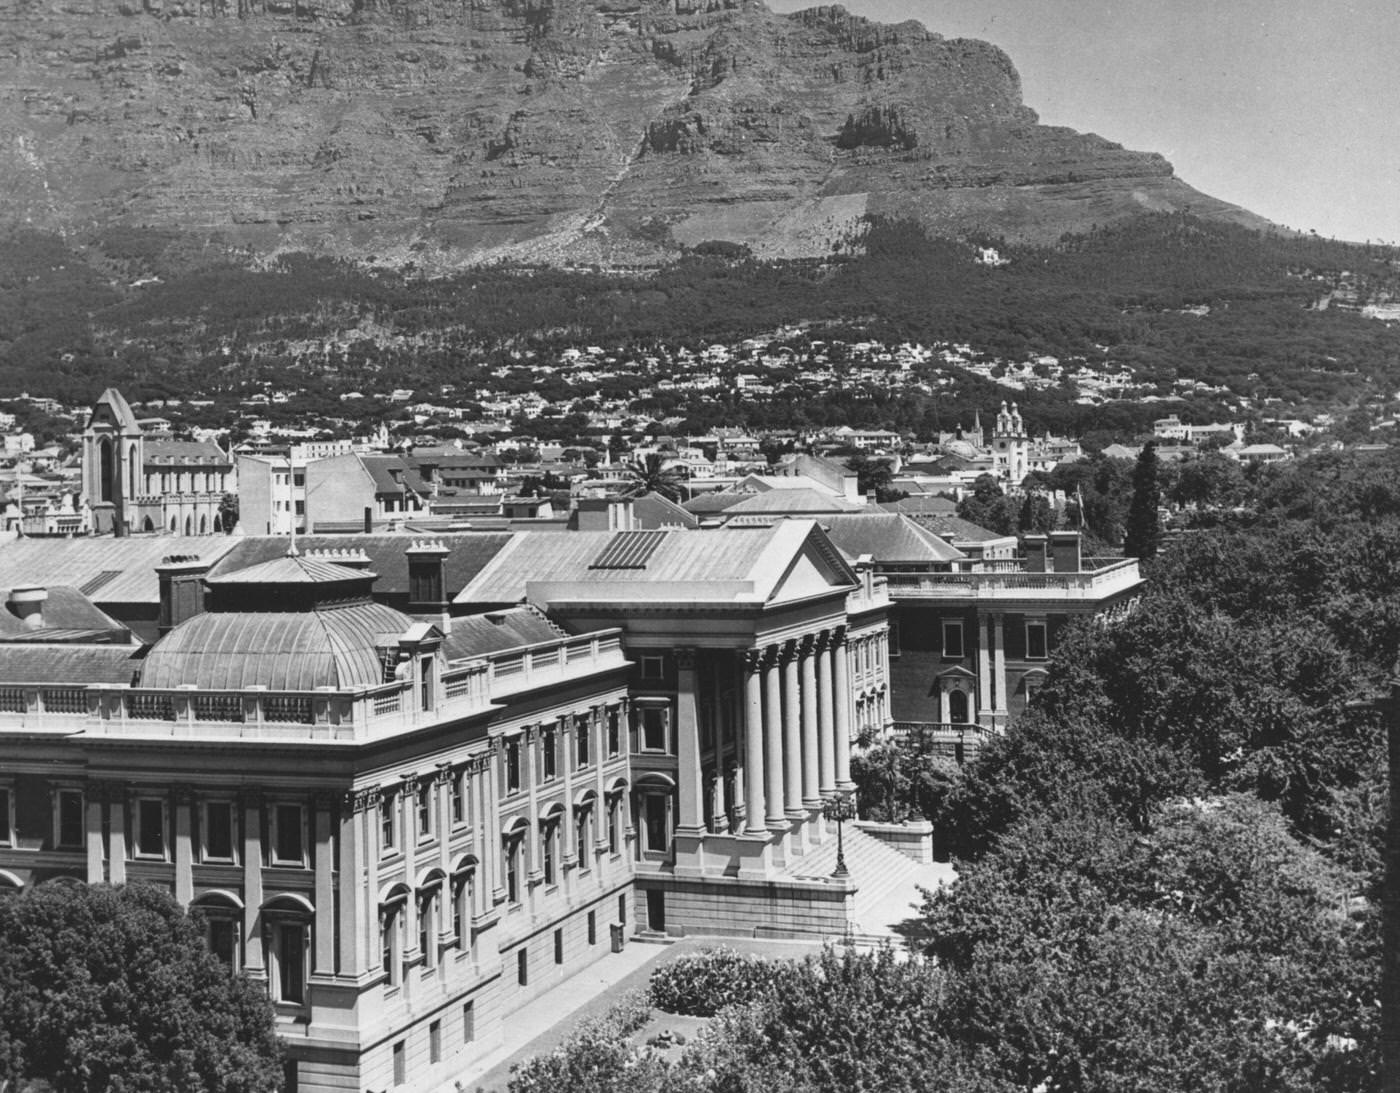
[458,521,889,933]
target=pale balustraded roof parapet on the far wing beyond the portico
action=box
[885,558,1142,603]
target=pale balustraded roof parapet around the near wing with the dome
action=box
[0,631,627,743]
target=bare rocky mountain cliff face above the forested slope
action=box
[0,0,1259,267]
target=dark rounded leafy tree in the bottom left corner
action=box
[0,880,281,1093]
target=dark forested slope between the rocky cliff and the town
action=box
[0,216,1400,428]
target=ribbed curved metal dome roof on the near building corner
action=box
[141,600,414,691]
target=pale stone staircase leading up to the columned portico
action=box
[784,824,955,945]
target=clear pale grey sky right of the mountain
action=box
[770,0,1400,242]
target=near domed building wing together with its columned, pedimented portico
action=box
[0,521,888,1090]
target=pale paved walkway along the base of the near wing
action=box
[435,938,822,1093]
